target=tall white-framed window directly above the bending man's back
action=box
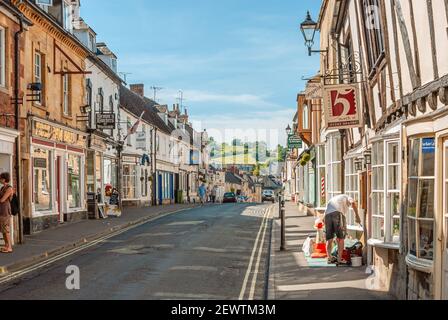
[326,135,342,200]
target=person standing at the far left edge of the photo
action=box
[0,172,14,253]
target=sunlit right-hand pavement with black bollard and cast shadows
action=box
[268,203,392,300]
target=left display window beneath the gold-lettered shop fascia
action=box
[33,149,53,211]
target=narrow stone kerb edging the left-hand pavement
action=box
[0,206,199,280]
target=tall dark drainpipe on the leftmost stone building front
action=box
[14,15,24,244]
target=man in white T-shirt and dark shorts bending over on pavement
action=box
[325,195,361,264]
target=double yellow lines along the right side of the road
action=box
[239,206,274,300]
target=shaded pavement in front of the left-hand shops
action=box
[0,205,195,277]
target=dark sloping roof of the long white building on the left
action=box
[120,85,172,135]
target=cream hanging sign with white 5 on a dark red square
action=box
[324,85,363,129]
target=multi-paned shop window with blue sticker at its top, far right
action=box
[408,138,435,261]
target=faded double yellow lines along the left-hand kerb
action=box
[0,208,195,285]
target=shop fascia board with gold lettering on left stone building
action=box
[33,120,86,148]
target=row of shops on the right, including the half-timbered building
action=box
[288,0,448,299]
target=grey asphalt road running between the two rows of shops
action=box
[0,204,271,300]
